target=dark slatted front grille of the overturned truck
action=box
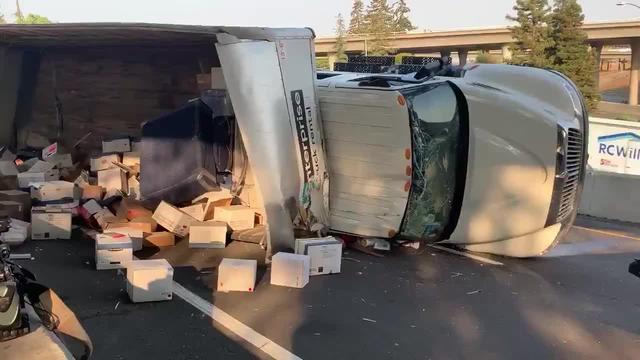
[557,129,583,222]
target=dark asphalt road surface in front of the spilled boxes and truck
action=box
[5,218,640,359]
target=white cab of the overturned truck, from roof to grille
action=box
[316,64,588,257]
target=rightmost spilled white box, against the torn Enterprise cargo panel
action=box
[295,236,342,276]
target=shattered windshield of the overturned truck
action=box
[400,82,468,241]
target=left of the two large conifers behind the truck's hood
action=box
[507,0,554,68]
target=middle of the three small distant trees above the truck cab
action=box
[365,0,394,55]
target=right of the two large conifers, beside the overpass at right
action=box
[550,0,600,108]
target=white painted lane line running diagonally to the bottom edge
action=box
[173,281,302,360]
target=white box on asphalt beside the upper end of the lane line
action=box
[218,259,258,292]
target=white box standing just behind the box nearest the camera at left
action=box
[96,233,133,270]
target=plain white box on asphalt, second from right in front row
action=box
[271,252,311,289]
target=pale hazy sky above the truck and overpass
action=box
[0,0,640,36]
